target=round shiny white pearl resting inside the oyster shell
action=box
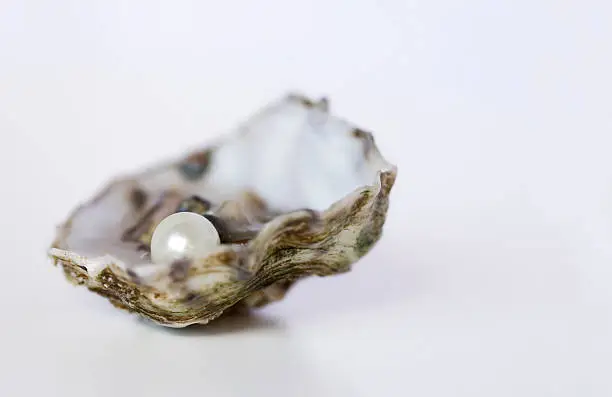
[151,212,220,264]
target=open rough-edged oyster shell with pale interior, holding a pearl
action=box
[49,95,396,327]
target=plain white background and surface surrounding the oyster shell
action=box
[0,0,612,397]
